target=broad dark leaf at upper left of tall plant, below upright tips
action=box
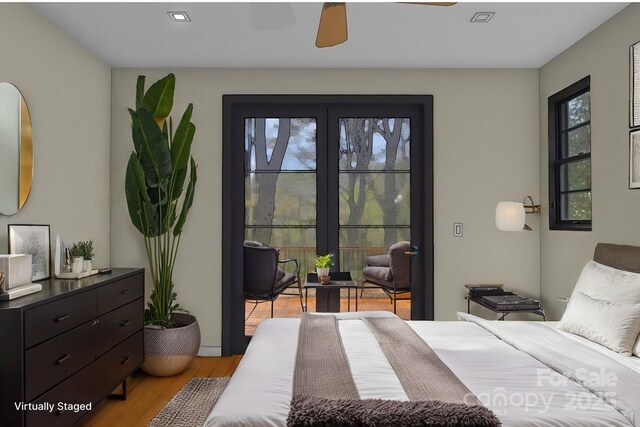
[129,108,172,187]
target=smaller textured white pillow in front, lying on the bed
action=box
[558,292,640,356]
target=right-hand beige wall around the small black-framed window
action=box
[540,4,640,319]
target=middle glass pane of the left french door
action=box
[244,172,316,227]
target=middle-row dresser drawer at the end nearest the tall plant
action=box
[96,298,144,354]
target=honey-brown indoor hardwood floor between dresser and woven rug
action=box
[82,356,242,427]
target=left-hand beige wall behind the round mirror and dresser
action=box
[0,3,111,266]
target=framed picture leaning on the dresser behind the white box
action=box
[8,224,51,282]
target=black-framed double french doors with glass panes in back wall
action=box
[222,95,433,355]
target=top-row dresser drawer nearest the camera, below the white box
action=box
[24,291,96,348]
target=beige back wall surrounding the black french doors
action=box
[111,69,540,354]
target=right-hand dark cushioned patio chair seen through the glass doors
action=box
[361,242,411,313]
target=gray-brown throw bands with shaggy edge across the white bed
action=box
[287,314,500,427]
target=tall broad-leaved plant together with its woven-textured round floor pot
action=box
[125,74,200,376]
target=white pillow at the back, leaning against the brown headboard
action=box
[571,261,640,304]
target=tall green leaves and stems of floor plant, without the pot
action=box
[125,74,197,328]
